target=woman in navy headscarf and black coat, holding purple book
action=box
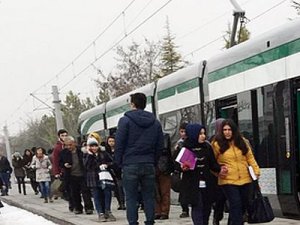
[180,124,224,225]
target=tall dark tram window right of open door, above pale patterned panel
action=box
[256,81,290,167]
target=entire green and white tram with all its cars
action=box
[79,20,300,219]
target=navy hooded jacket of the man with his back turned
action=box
[115,109,163,167]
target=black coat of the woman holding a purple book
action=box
[179,139,221,205]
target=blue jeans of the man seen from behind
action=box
[123,164,155,225]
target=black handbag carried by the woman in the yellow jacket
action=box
[248,181,274,223]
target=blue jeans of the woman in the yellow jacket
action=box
[221,183,251,225]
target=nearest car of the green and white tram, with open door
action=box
[207,20,300,216]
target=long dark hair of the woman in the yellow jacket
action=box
[215,119,248,155]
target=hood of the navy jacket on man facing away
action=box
[125,109,155,128]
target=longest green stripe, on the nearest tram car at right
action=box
[208,39,300,83]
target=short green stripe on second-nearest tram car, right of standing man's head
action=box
[157,77,199,100]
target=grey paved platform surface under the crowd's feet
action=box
[1,184,300,225]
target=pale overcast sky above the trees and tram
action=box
[0,0,297,135]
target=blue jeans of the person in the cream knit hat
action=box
[92,187,112,214]
